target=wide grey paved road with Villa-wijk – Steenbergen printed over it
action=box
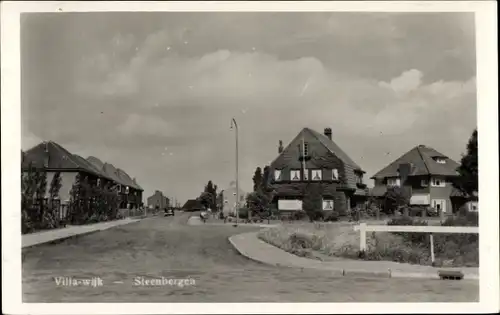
[23,214,479,302]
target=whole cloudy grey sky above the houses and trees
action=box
[21,12,477,201]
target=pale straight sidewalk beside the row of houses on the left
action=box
[22,218,141,248]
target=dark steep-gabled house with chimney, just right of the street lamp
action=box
[270,128,367,215]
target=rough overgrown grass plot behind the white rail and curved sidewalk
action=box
[259,220,479,267]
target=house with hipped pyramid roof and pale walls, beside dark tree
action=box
[372,145,467,216]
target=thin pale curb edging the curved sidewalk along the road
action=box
[228,233,479,281]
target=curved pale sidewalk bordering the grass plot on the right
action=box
[229,232,479,280]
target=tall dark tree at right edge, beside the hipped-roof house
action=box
[453,129,479,196]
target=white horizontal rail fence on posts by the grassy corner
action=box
[354,223,479,262]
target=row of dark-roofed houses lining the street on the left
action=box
[21,141,144,209]
